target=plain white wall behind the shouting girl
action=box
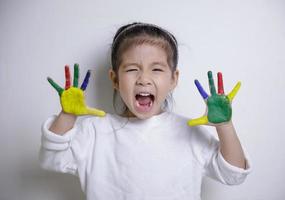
[0,0,285,200]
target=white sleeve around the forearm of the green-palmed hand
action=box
[189,127,251,185]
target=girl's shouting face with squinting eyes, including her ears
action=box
[110,44,178,119]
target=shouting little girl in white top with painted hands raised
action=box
[40,23,250,200]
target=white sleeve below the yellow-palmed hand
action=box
[39,116,95,175]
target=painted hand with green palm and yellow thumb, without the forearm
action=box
[188,71,241,126]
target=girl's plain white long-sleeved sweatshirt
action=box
[40,112,250,200]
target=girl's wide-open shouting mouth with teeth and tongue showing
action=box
[135,92,155,112]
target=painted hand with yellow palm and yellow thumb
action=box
[48,64,105,117]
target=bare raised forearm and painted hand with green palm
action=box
[188,71,246,168]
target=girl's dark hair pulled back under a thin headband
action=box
[111,22,178,113]
